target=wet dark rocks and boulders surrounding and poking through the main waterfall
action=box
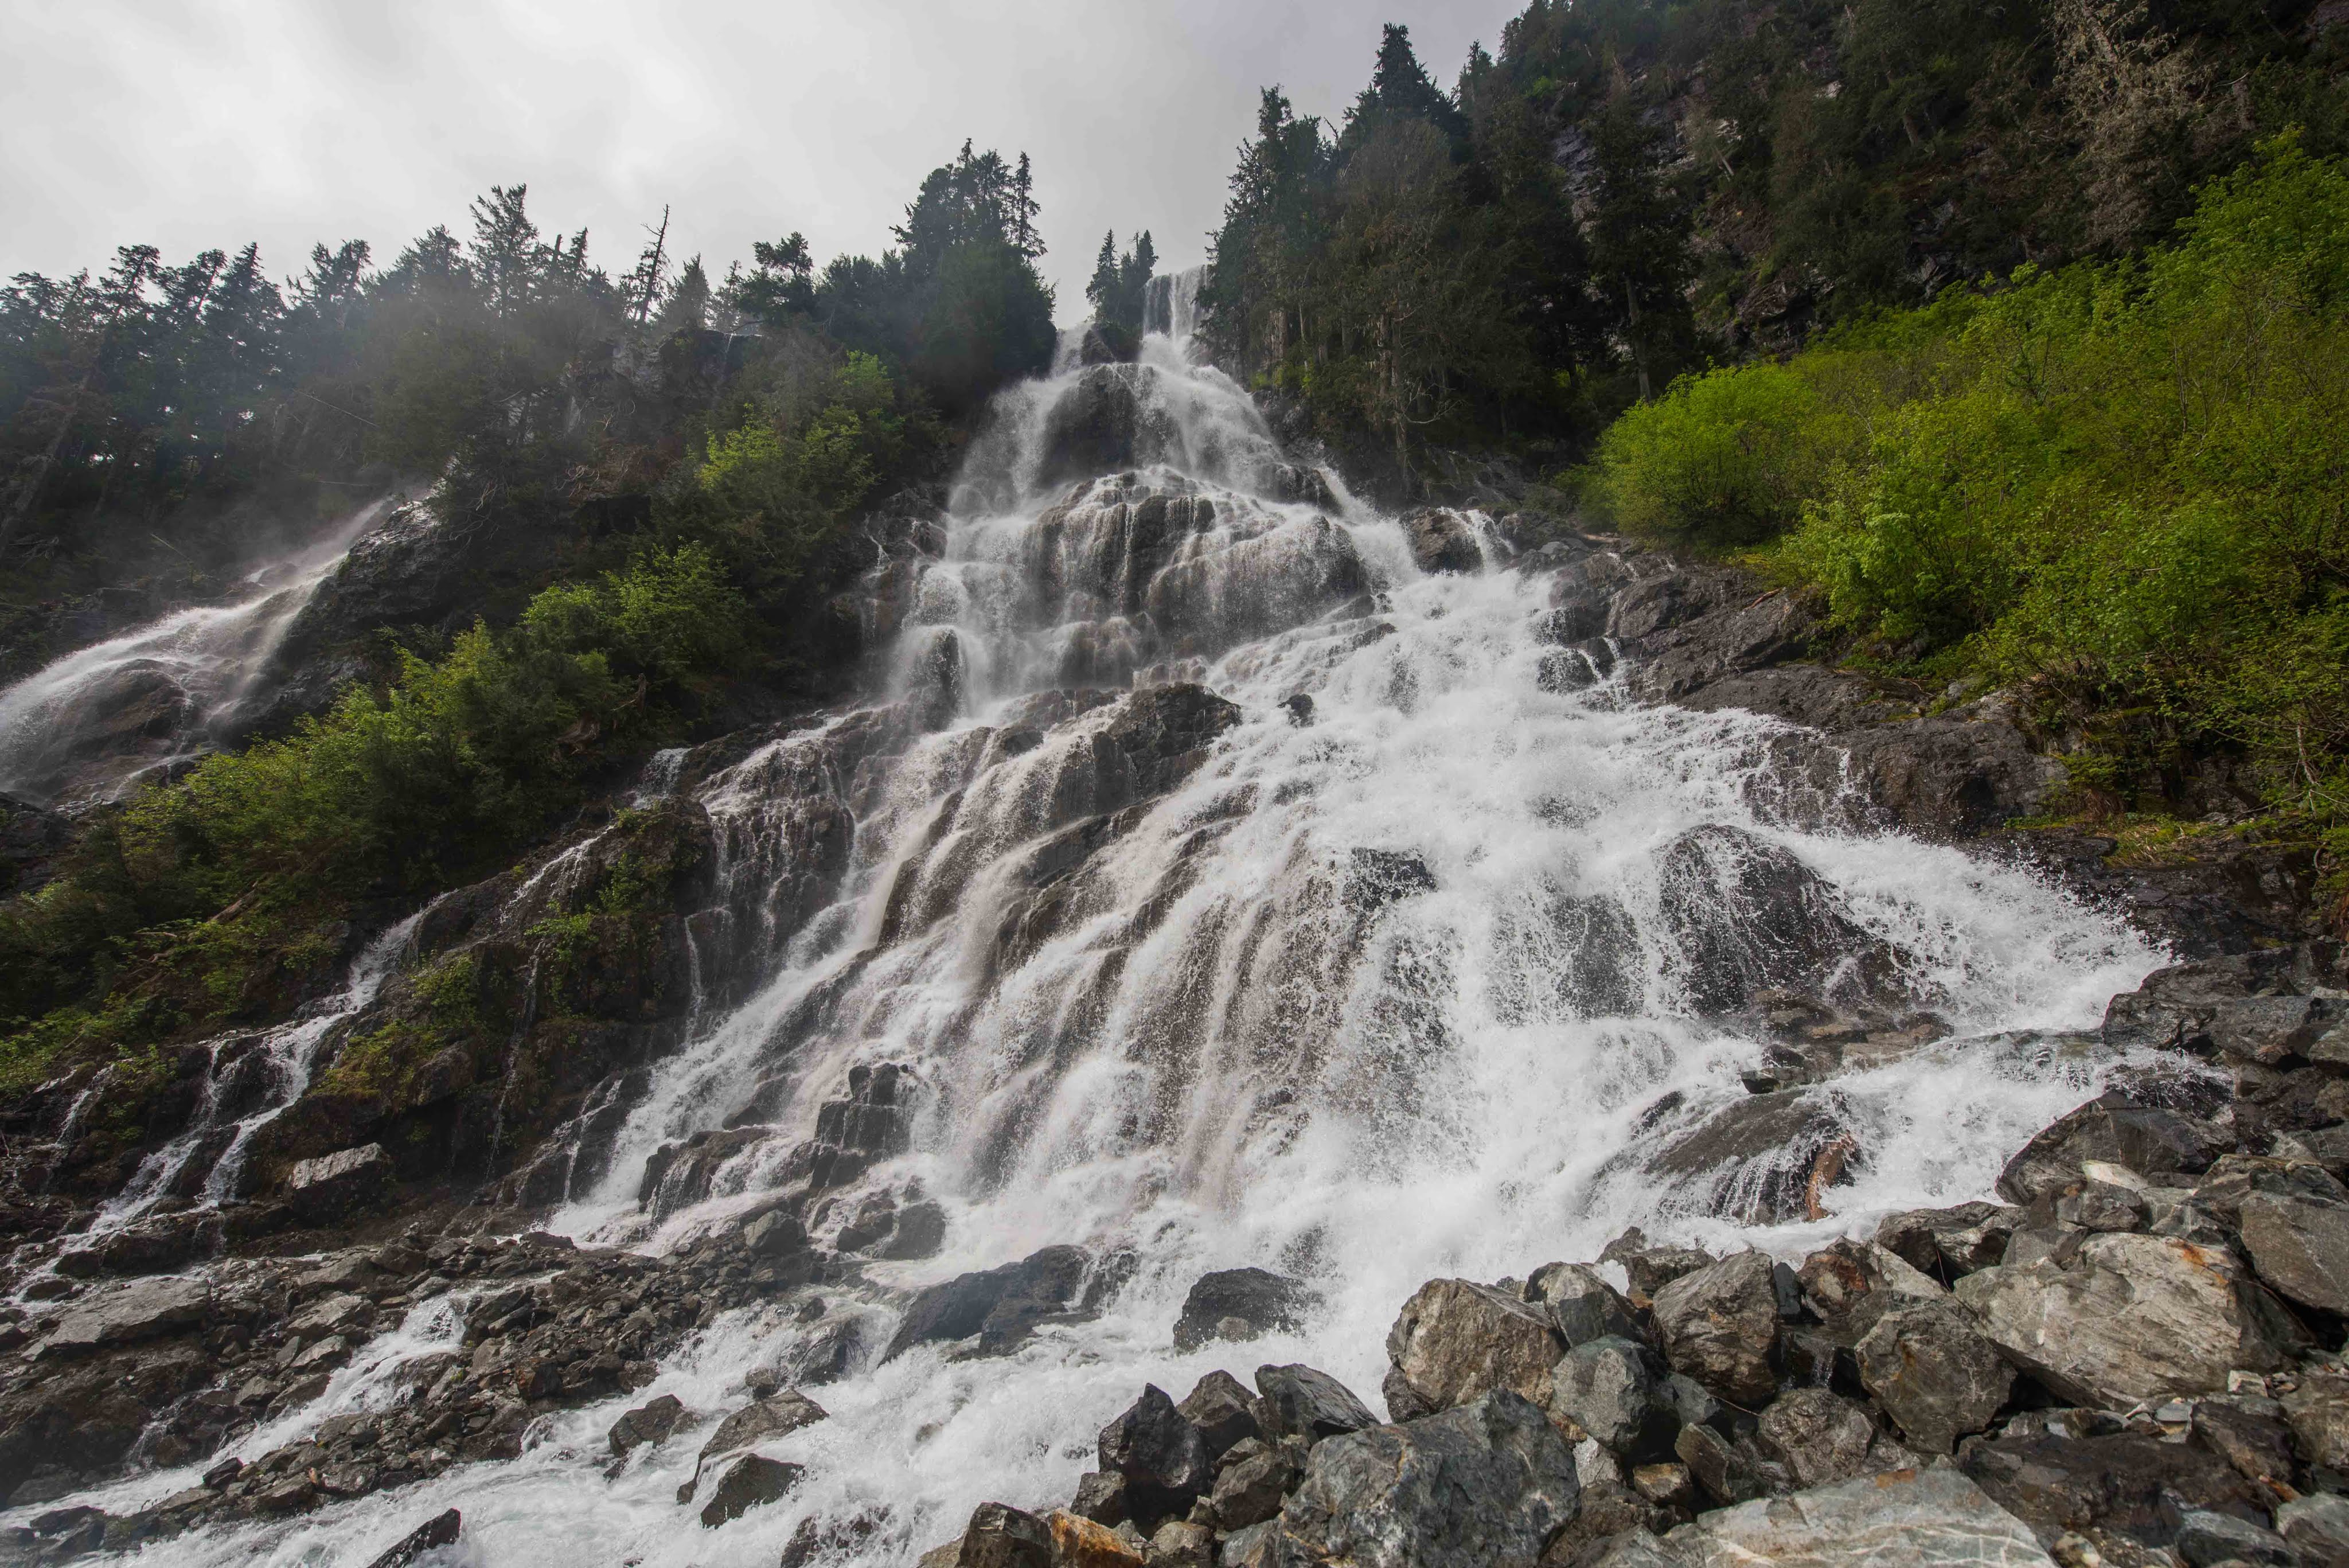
[0,350,2320,1568]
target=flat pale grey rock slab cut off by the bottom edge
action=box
[1663,1469,2053,1568]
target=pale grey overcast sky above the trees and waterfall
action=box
[0,0,1517,319]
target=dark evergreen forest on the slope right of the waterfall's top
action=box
[1200,0,2349,463]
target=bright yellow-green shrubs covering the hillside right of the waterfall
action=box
[1586,136,2349,841]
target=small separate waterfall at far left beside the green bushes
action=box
[0,496,399,806]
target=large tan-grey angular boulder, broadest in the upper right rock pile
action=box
[1957,1232,2293,1410]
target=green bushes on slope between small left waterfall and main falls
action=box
[0,543,747,1082]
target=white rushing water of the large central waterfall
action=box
[133,297,2161,1568]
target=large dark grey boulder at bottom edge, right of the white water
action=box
[1273,1387,1581,1568]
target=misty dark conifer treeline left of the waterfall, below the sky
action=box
[0,143,1052,597]
